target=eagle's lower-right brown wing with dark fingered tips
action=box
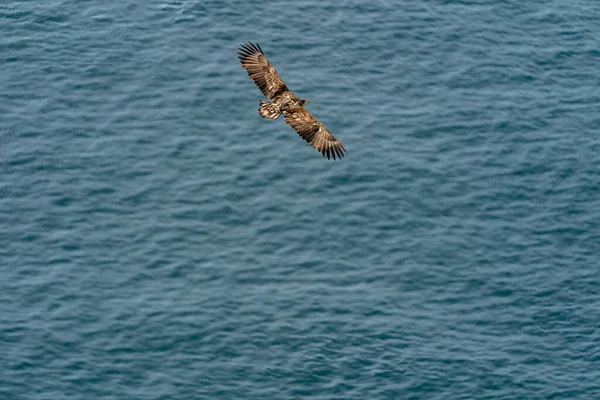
[284,106,348,160]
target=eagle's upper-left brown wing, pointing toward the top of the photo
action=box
[238,42,289,100]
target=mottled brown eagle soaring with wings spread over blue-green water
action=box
[237,42,348,160]
